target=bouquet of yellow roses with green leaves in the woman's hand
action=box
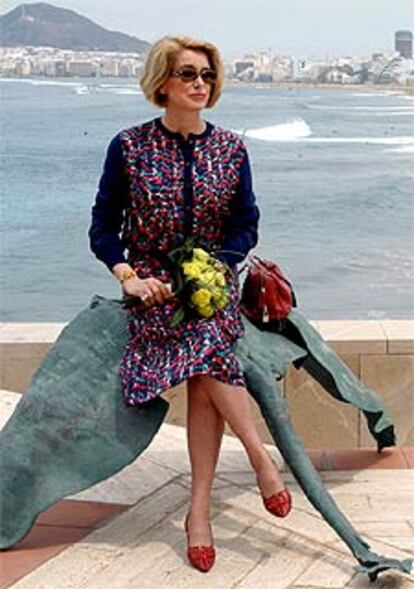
[124,236,229,327]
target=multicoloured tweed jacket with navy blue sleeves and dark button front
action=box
[89,117,259,274]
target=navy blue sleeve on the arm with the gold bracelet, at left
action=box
[88,135,128,271]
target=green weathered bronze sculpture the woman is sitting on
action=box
[0,295,412,580]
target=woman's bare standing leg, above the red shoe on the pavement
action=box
[187,375,224,546]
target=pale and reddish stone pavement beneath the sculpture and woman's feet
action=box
[0,391,414,589]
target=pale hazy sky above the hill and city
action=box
[0,0,414,59]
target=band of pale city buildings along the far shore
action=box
[0,43,414,87]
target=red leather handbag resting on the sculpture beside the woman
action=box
[240,256,297,328]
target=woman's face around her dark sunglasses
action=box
[160,49,212,111]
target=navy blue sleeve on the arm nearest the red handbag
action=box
[215,151,260,266]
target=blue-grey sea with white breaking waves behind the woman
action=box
[0,78,414,322]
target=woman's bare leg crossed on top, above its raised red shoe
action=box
[196,375,285,497]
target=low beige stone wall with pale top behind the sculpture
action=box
[0,319,414,450]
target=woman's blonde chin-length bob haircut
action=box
[140,35,224,108]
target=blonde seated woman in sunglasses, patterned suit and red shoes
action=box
[89,36,291,571]
